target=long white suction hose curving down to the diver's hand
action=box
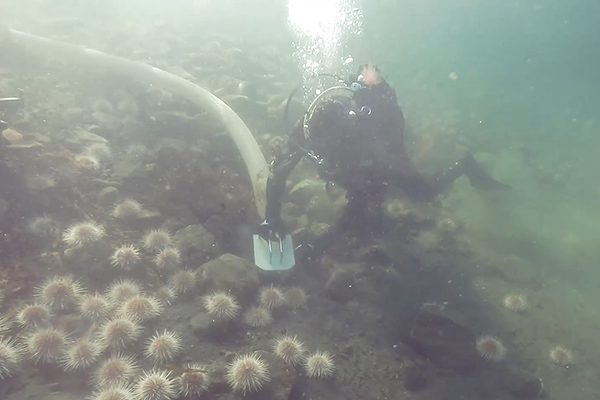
[0,29,269,219]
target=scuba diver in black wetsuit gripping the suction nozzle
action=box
[258,64,508,253]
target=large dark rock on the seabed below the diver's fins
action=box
[408,305,481,371]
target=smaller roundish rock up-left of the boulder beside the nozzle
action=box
[173,224,219,266]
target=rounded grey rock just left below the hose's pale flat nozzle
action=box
[198,254,260,304]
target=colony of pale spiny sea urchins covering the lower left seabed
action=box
[0,194,324,400]
